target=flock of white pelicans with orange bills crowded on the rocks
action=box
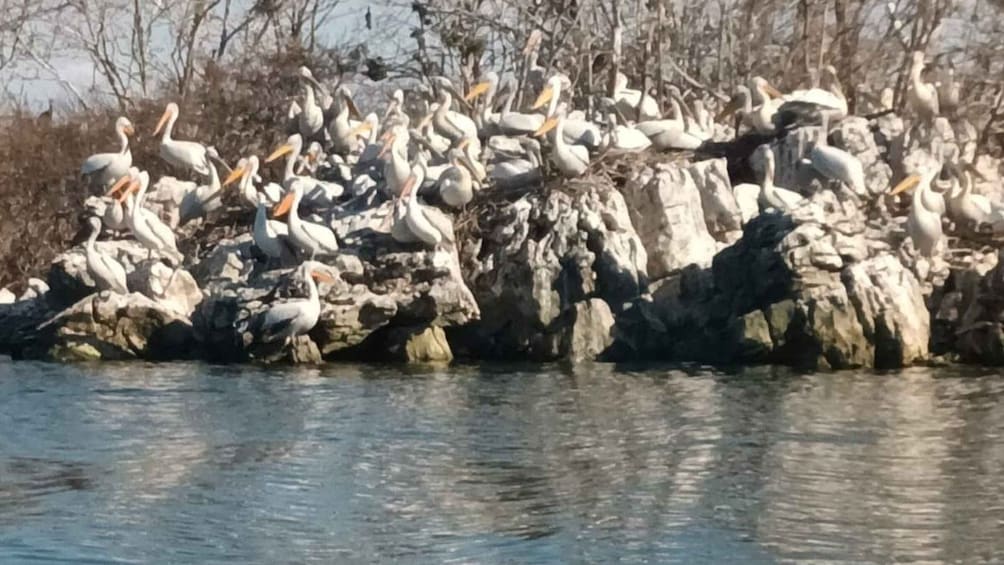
[66,43,1004,353]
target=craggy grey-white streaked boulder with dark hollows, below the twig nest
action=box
[459,180,646,359]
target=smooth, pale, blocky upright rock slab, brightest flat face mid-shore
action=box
[621,162,720,279]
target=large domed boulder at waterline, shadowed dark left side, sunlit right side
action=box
[655,192,930,368]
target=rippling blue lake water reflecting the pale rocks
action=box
[0,362,1004,564]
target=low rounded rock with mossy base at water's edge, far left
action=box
[21,292,195,361]
